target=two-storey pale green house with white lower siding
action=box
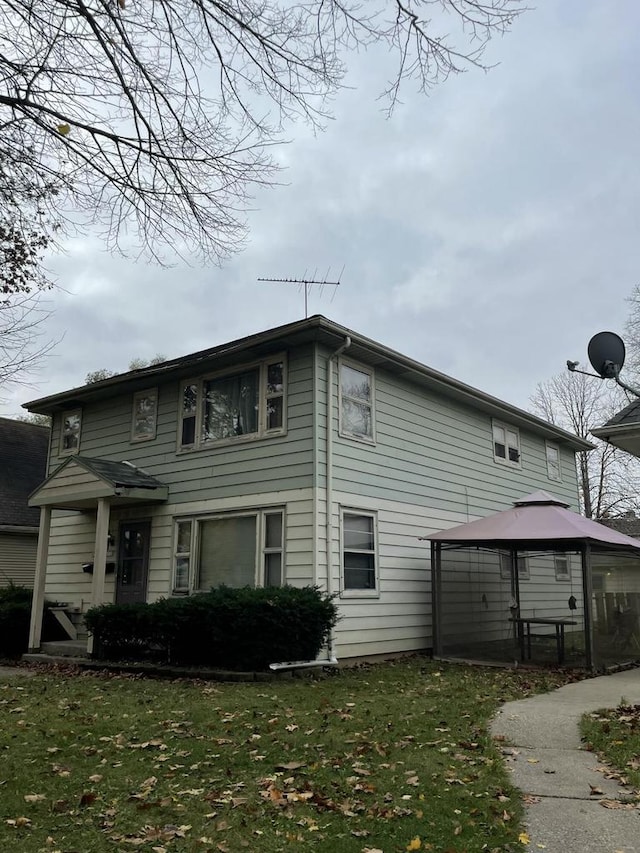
[26,316,590,658]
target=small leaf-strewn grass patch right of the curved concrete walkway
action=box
[580,699,640,800]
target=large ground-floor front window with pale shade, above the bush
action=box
[173,509,284,592]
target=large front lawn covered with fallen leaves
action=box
[0,658,563,853]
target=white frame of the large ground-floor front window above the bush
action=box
[171,506,287,595]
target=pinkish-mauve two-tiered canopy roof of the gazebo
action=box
[424,491,640,556]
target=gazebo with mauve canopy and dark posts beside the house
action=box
[425,491,640,669]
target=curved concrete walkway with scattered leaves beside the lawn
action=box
[491,669,640,853]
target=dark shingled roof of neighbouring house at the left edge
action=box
[0,418,49,530]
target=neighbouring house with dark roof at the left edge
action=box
[0,418,49,587]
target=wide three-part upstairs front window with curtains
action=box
[179,357,285,449]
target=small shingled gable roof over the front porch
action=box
[29,456,169,510]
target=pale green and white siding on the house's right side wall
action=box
[317,352,578,657]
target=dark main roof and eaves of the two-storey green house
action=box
[25,315,592,450]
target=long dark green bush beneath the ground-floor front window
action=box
[87,586,337,670]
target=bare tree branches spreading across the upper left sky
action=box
[0,0,525,261]
